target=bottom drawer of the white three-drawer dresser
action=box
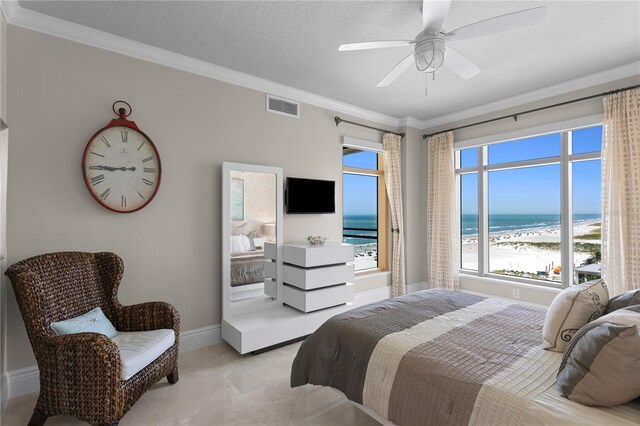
[282,284,353,312]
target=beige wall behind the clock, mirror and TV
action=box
[8,26,419,370]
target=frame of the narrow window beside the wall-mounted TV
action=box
[342,151,389,275]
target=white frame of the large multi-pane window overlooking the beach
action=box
[454,115,603,289]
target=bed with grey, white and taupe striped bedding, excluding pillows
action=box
[291,289,640,425]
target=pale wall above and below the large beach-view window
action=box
[422,76,640,305]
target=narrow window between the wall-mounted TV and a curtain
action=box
[342,146,387,272]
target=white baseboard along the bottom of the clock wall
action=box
[1,282,425,402]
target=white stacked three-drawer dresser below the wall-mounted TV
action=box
[283,242,354,312]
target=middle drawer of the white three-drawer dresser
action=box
[283,264,353,290]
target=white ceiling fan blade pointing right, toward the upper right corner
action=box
[445,6,547,41]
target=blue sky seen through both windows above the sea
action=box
[343,126,602,220]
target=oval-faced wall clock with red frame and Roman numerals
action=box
[82,101,162,213]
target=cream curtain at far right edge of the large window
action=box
[602,89,640,294]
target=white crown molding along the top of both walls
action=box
[2,0,640,131]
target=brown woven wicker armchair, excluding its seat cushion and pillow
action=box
[6,252,180,425]
